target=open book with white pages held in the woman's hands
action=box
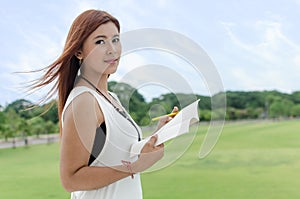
[130,99,200,157]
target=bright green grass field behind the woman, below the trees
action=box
[0,120,300,199]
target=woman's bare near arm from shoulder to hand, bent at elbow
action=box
[60,93,163,192]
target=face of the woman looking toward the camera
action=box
[80,22,122,75]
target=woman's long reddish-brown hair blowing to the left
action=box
[32,10,120,132]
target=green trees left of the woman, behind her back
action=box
[0,99,58,140]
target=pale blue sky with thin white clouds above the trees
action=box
[0,0,300,105]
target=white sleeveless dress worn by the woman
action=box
[62,86,142,199]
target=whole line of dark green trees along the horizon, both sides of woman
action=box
[0,82,300,139]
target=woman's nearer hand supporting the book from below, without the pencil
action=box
[132,135,164,173]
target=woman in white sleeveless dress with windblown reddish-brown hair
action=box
[35,10,178,199]
